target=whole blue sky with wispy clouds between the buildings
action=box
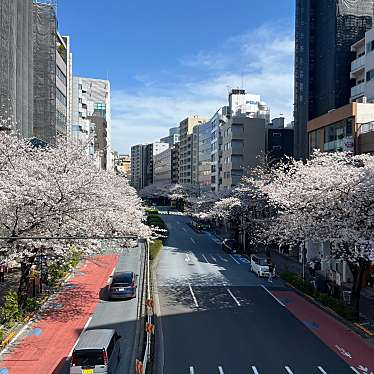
[58,0,294,153]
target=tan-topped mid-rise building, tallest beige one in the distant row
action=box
[179,116,207,184]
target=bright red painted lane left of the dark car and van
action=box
[0,255,118,374]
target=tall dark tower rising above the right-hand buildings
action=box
[294,0,374,159]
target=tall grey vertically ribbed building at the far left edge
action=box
[0,0,34,137]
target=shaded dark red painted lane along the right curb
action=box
[272,291,374,374]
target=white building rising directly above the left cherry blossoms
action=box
[72,77,114,170]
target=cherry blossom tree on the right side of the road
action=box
[248,152,374,317]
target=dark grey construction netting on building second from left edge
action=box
[33,3,57,143]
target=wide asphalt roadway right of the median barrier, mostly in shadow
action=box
[157,215,352,374]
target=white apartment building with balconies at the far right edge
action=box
[351,29,374,103]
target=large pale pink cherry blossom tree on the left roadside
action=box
[0,131,151,305]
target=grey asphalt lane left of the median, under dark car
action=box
[61,248,143,374]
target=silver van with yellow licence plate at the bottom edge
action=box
[70,329,121,374]
